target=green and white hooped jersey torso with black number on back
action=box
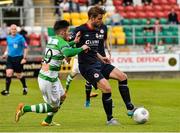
[38,36,70,82]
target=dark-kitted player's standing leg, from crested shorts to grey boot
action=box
[79,64,118,125]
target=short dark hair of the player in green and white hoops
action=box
[53,20,69,33]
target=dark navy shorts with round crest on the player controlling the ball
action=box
[79,62,115,89]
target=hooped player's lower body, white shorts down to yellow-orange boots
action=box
[15,78,65,126]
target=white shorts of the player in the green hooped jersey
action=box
[38,77,65,107]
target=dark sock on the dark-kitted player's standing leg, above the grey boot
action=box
[102,93,113,121]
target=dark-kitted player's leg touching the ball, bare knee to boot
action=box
[109,68,135,116]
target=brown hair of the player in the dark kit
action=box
[88,6,106,19]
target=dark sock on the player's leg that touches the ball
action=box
[119,79,134,110]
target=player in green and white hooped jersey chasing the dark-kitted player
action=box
[15,20,89,126]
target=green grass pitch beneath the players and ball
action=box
[0,79,180,132]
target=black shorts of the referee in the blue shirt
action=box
[6,56,23,73]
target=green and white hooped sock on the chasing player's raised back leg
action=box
[23,103,53,113]
